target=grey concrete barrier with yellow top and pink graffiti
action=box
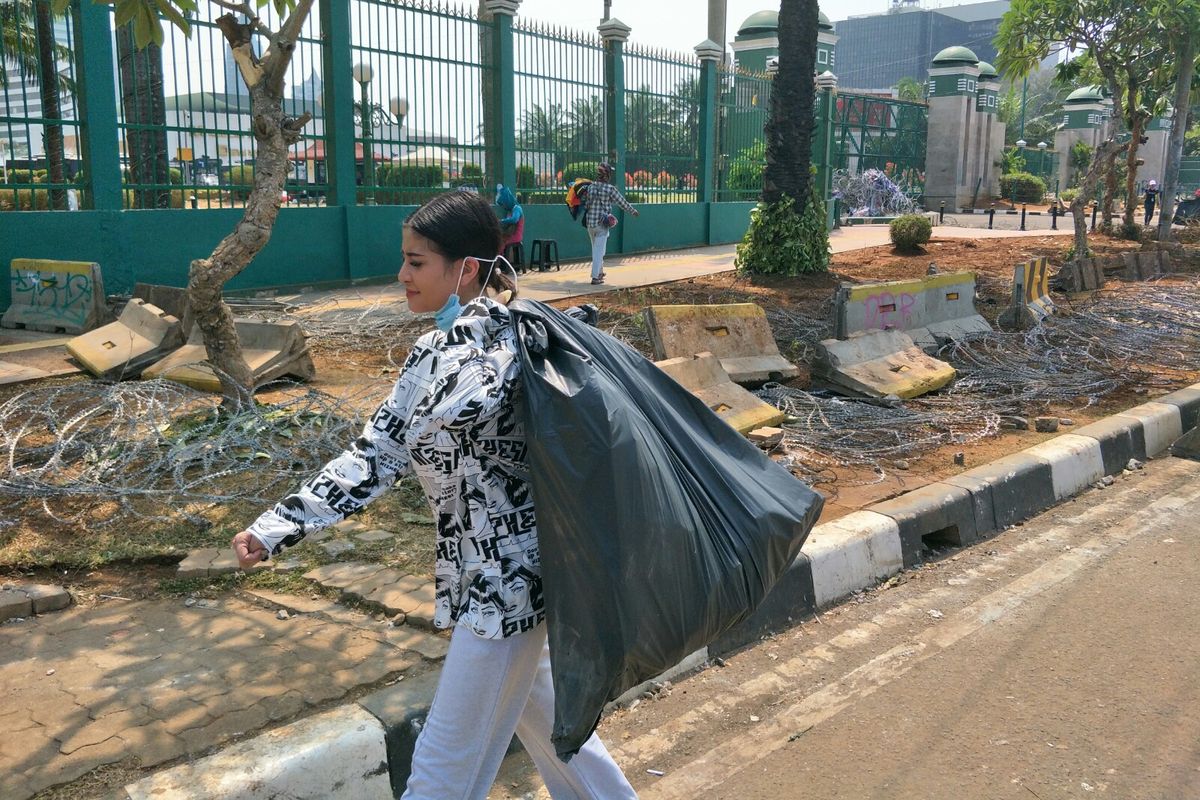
[834,272,991,350]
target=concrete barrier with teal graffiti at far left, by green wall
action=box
[0,258,112,333]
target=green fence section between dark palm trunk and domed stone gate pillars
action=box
[833,94,929,198]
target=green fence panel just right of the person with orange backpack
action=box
[623,46,701,203]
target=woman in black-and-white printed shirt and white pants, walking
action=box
[233,192,637,800]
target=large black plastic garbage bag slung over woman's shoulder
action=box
[509,300,823,760]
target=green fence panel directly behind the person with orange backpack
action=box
[512,22,611,203]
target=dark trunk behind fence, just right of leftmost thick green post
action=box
[116,23,170,209]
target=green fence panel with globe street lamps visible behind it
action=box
[350,0,498,205]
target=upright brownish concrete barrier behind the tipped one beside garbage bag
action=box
[643,302,800,384]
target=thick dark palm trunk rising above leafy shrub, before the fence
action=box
[762,0,820,206]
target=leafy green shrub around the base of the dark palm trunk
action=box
[733,187,829,275]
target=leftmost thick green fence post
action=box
[73,1,124,211]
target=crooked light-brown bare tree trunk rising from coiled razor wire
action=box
[187,0,314,409]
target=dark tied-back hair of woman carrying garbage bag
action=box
[404,192,517,299]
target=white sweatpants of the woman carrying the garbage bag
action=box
[402,625,637,800]
